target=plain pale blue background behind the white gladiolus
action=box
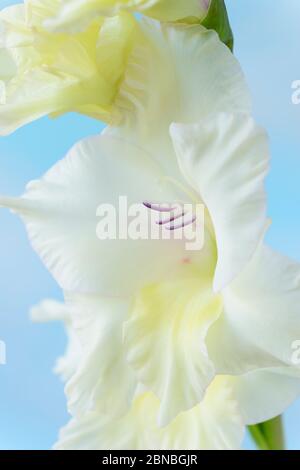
[0,0,300,449]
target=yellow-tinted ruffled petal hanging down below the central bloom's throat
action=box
[124,276,221,426]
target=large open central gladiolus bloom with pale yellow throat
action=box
[0,22,300,434]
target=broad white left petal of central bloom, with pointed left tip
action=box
[0,136,201,296]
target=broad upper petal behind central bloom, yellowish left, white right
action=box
[112,20,251,165]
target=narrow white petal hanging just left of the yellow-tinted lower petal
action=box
[65,294,137,417]
